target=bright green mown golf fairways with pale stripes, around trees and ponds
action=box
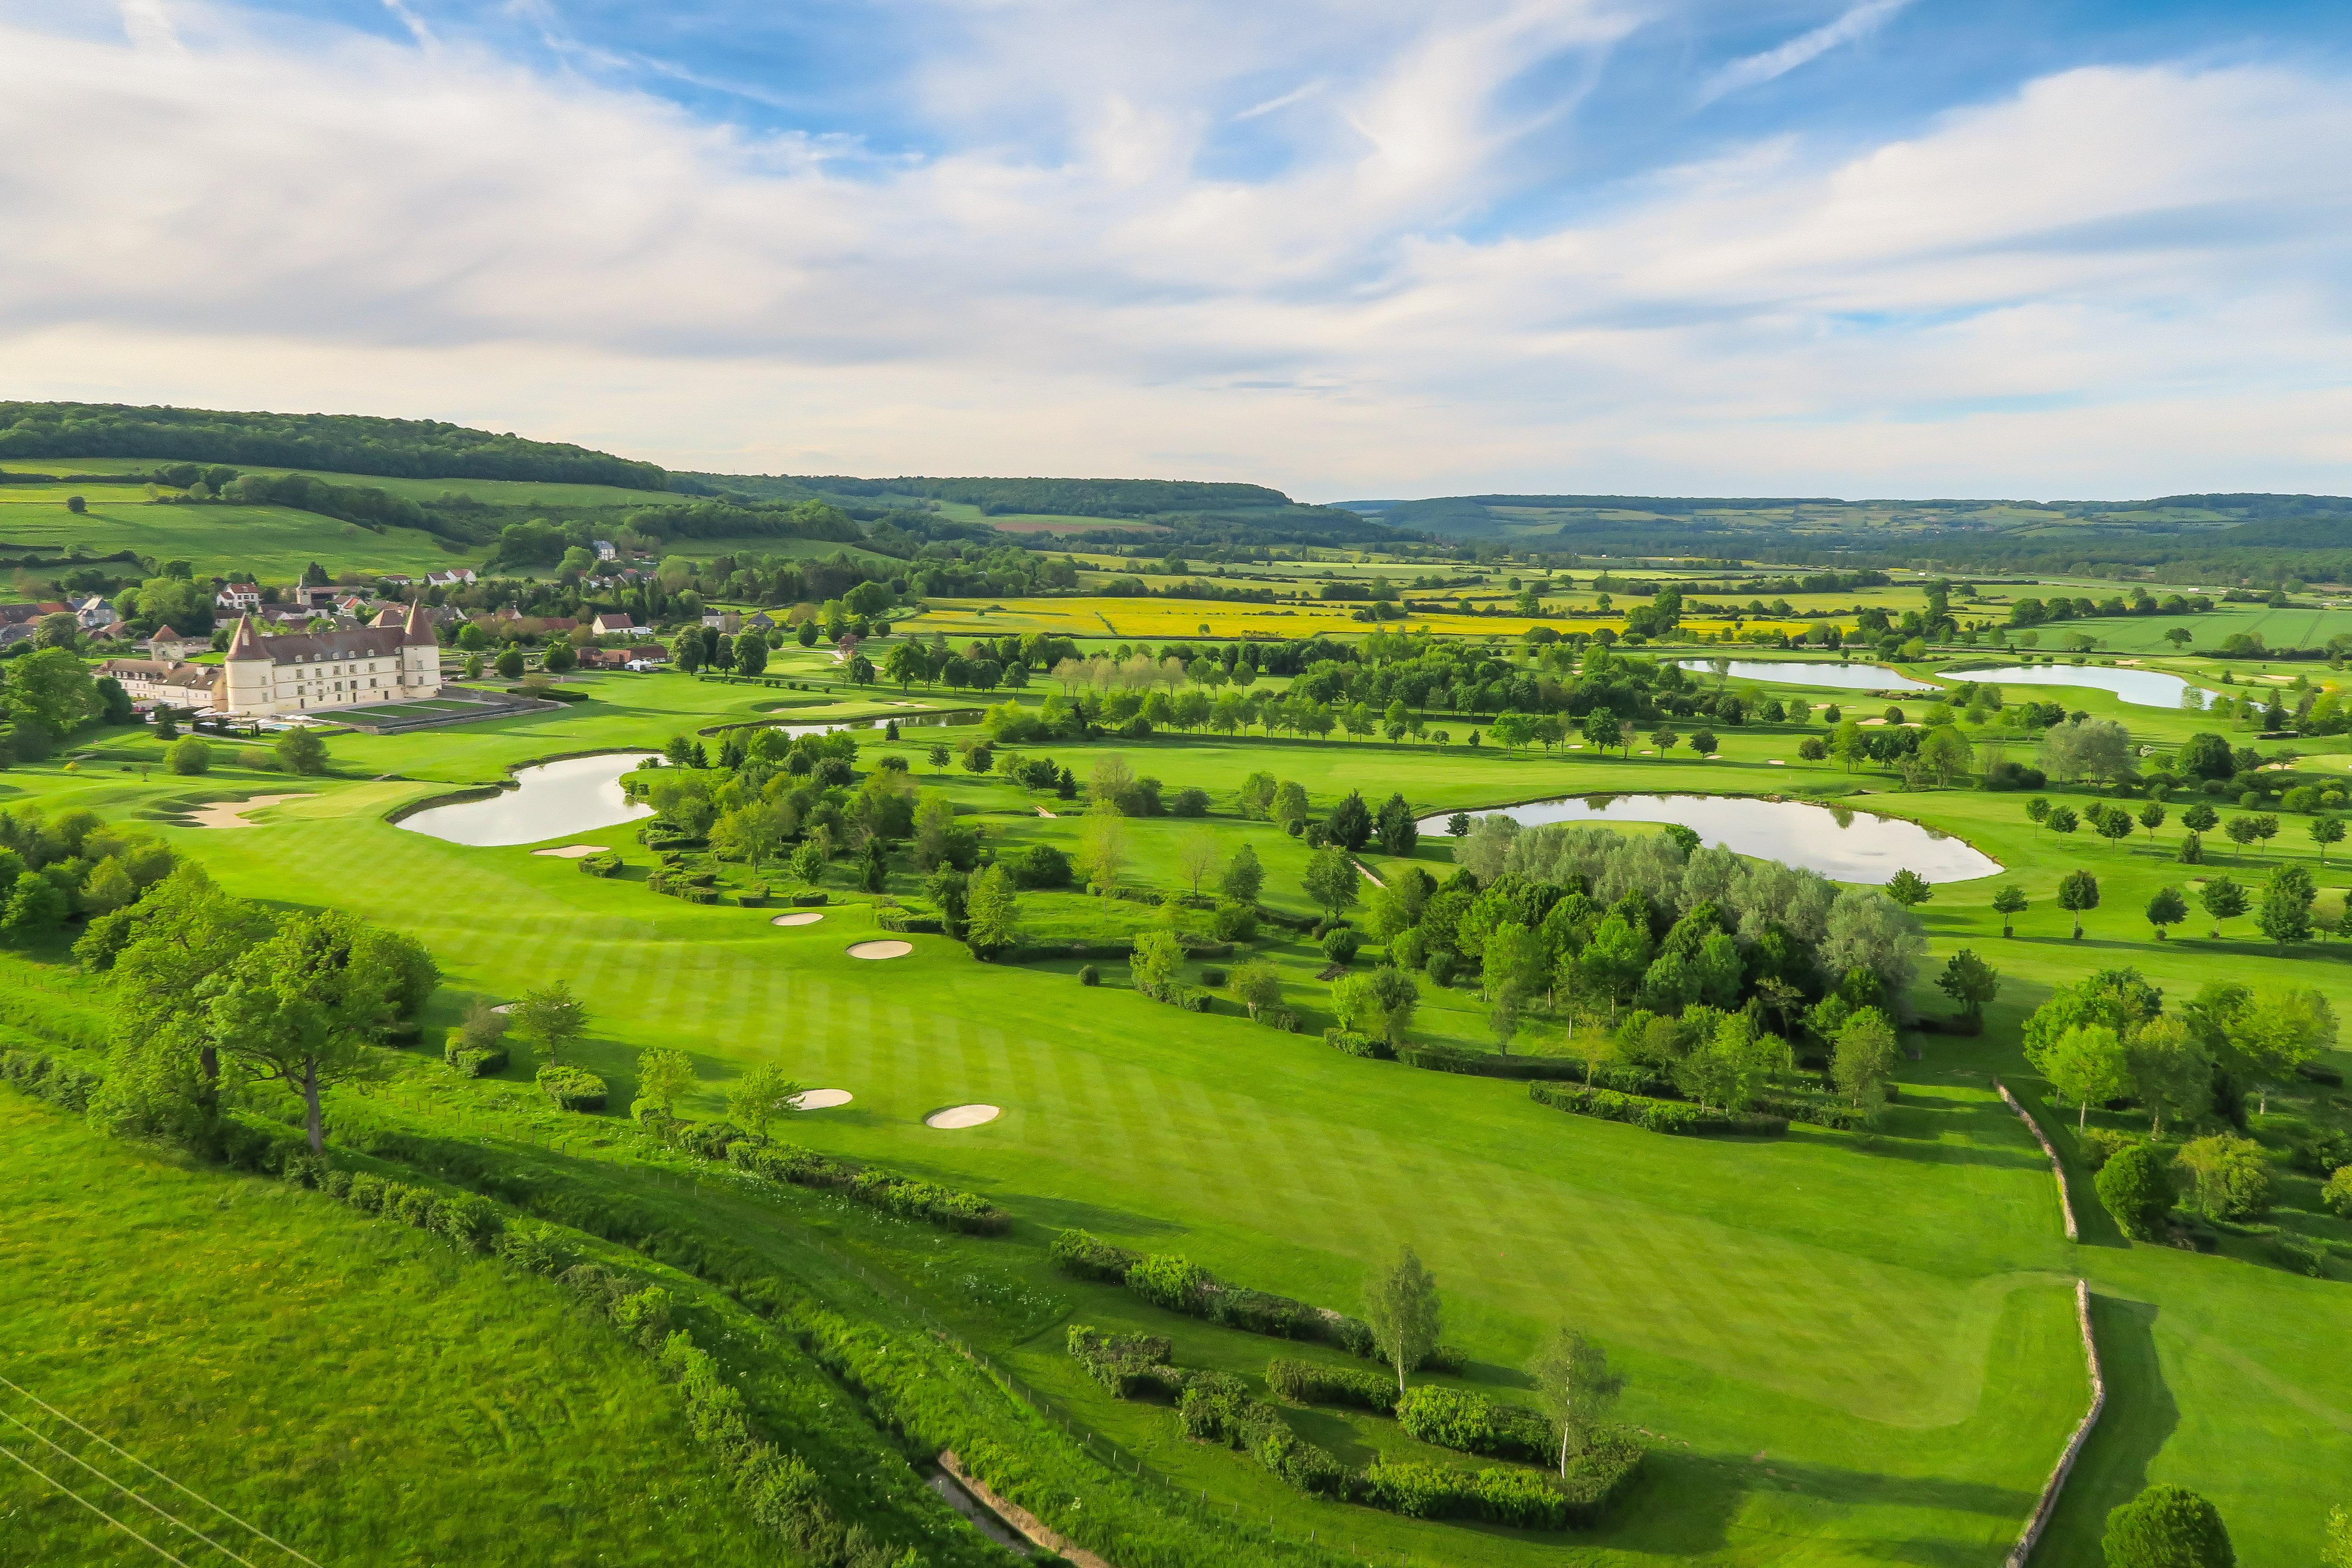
[18,677,2352,1566]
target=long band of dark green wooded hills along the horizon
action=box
[0,402,2352,581]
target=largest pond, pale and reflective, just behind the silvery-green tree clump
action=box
[1420,794,2002,884]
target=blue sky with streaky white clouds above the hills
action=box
[0,0,2352,501]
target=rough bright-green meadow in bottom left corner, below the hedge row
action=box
[0,1091,774,1568]
